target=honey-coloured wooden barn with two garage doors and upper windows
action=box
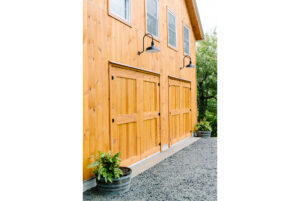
[83,0,204,181]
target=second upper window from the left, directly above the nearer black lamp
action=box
[146,0,158,38]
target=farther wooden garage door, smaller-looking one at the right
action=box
[169,78,192,145]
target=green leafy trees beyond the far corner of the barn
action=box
[196,31,217,136]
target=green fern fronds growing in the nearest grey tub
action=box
[88,151,123,183]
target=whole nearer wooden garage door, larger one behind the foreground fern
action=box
[110,66,160,165]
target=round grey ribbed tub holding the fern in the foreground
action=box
[96,167,132,195]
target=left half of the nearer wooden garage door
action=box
[110,68,138,164]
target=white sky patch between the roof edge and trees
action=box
[196,0,217,33]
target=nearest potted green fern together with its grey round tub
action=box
[88,151,132,194]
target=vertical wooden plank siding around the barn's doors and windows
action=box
[83,0,197,180]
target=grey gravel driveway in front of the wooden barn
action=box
[83,138,217,201]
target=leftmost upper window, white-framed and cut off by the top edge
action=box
[109,0,130,22]
